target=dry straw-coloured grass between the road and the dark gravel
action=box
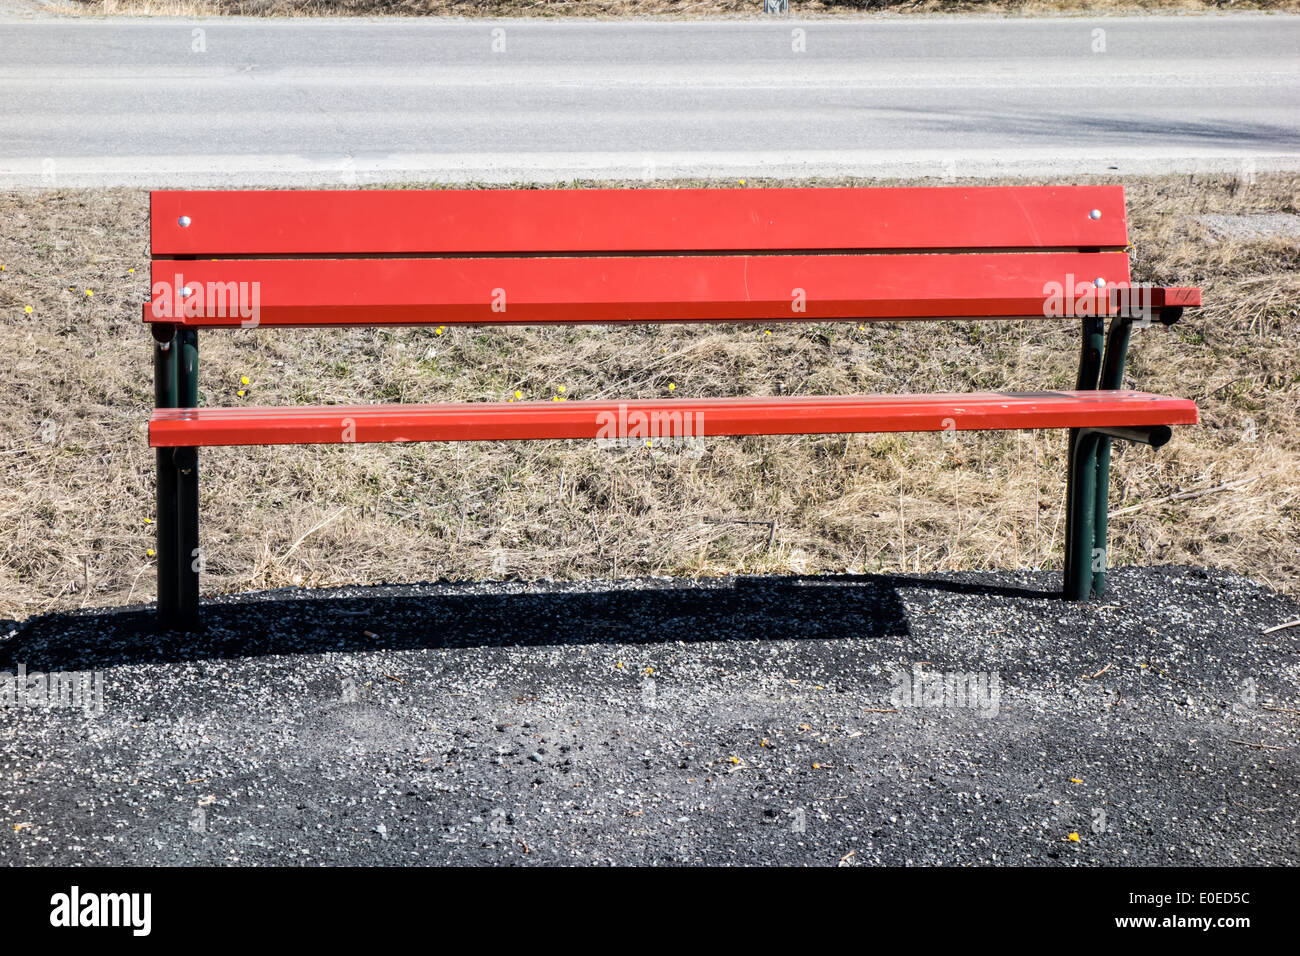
[0,176,1300,615]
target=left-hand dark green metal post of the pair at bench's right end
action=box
[1063,316,1106,601]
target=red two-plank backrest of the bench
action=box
[144,186,1130,326]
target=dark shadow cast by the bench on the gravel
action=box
[0,575,1058,674]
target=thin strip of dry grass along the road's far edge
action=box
[51,0,1300,18]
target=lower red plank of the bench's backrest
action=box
[144,252,1128,326]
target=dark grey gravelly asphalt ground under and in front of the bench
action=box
[0,567,1300,865]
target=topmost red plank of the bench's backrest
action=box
[150,186,1128,258]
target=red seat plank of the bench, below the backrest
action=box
[150,392,1197,447]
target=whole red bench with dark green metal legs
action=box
[144,186,1200,630]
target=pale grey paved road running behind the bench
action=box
[0,16,1300,186]
